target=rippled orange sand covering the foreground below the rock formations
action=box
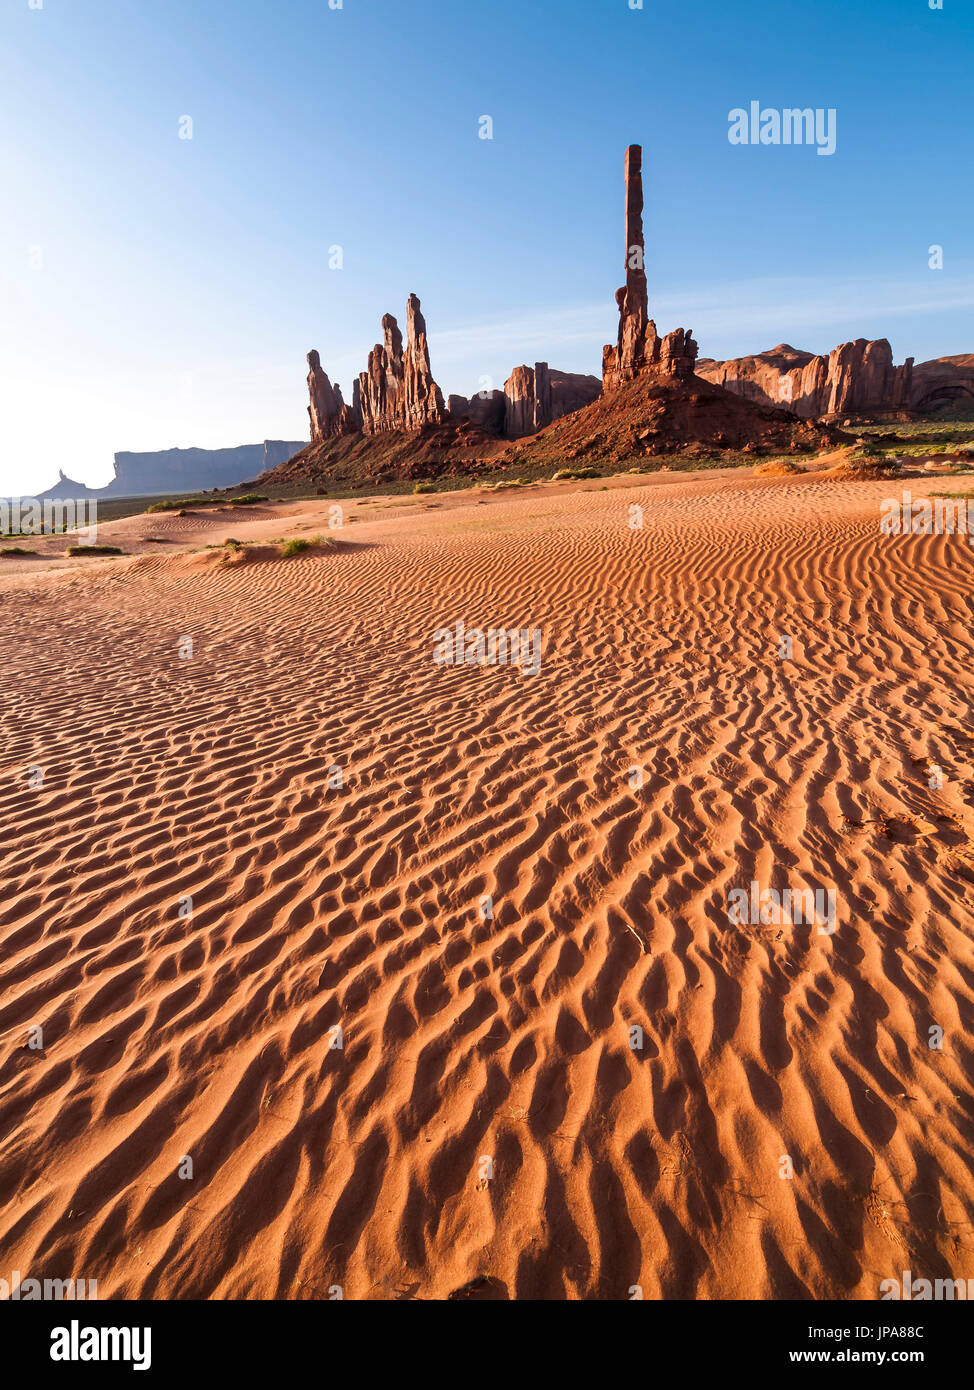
[0,475,974,1298]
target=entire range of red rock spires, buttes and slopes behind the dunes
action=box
[295,136,974,483]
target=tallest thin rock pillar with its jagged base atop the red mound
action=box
[602,145,696,395]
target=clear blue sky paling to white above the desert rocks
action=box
[0,0,974,493]
